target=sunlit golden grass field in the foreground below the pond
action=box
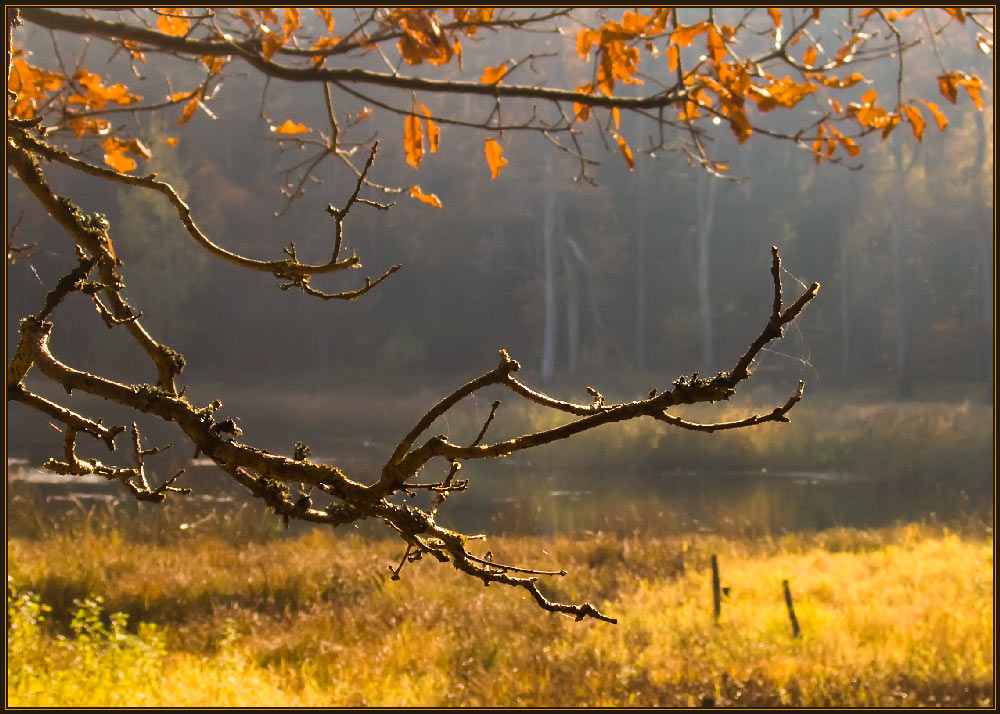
[7,523,995,707]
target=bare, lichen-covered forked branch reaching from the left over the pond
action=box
[7,132,819,622]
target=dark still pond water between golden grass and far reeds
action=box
[8,459,993,536]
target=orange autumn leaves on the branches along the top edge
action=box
[7,7,992,192]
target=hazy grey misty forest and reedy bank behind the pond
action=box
[7,11,994,536]
